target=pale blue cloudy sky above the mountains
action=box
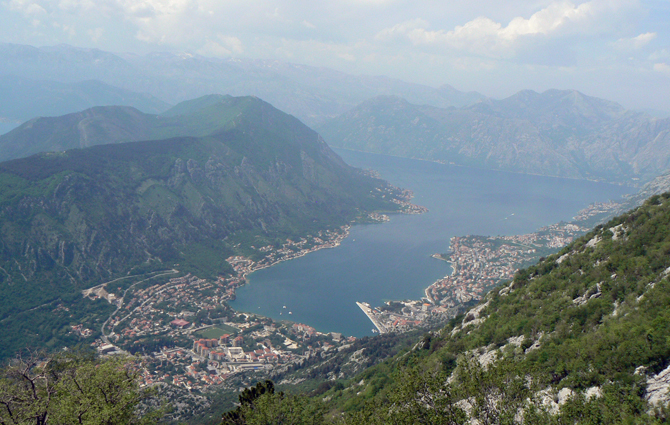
[0,0,670,111]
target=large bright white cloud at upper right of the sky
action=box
[375,0,648,57]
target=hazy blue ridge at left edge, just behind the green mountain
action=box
[0,75,170,130]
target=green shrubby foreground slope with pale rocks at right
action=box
[236,193,670,424]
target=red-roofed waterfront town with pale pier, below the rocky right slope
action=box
[358,220,602,333]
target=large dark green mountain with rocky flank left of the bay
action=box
[0,97,397,354]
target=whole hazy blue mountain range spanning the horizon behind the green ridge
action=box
[0,44,670,186]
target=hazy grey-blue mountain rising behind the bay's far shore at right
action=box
[316,90,670,184]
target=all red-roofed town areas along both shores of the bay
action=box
[77,196,609,391]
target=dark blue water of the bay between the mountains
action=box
[232,150,632,336]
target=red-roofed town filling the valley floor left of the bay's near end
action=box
[84,225,368,391]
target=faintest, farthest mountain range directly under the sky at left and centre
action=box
[0,44,484,125]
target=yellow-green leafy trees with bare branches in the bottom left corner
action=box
[0,352,161,425]
